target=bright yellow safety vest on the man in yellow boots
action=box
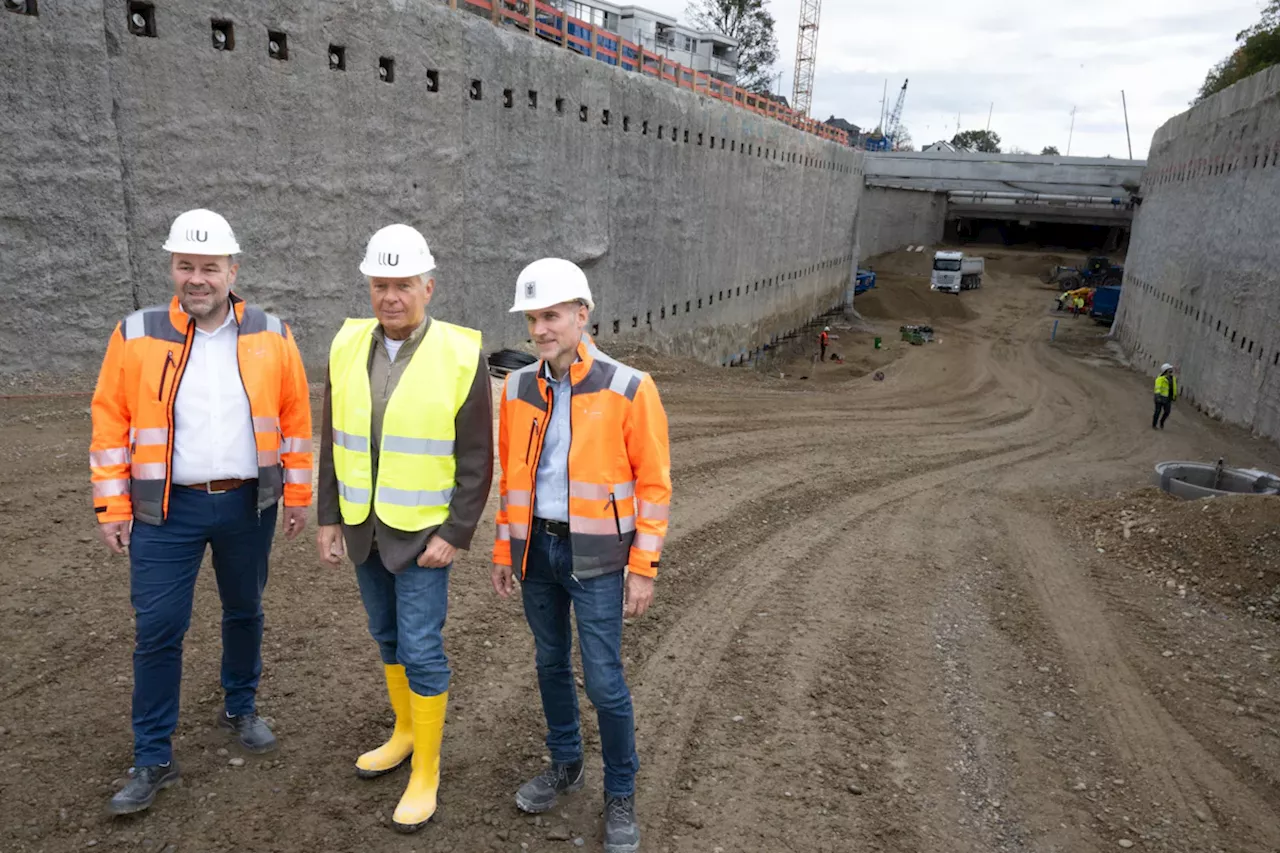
[329,319,480,532]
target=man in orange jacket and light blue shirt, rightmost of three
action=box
[493,257,671,853]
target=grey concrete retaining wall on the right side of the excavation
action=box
[1115,68,1280,439]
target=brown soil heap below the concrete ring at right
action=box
[1059,487,1280,620]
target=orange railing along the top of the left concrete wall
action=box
[447,0,849,145]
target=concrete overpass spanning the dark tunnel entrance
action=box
[867,151,1146,235]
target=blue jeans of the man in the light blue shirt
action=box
[521,525,640,797]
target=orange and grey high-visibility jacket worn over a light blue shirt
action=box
[493,336,671,580]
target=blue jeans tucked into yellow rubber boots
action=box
[356,548,451,695]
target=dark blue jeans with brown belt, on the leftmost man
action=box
[129,483,275,767]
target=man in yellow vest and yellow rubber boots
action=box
[316,224,493,833]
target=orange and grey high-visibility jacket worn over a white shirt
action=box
[88,293,311,524]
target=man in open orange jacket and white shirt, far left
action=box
[90,210,311,815]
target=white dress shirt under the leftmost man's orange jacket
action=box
[173,310,257,485]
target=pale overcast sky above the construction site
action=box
[645,0,1265,159]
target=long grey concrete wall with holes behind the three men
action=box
[0,0,863,378]
